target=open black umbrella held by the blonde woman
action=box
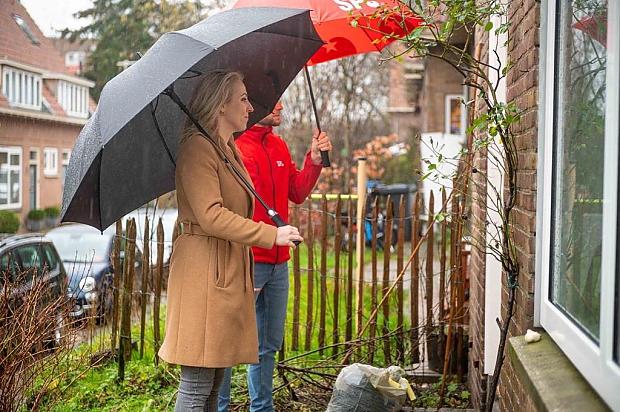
[61,8,323,229]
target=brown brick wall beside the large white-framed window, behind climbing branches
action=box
[468,0,540,411]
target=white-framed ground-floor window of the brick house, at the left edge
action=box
[0,147,22,209]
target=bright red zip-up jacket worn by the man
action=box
[235,125,321,264]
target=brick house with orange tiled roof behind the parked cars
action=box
[0,0,94,227]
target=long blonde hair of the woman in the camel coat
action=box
[181,70,243,143]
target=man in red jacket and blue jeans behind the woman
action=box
[219,102,331,412]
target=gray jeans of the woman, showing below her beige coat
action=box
[174,365,224,412]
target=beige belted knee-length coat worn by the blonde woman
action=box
[159,135,276,368]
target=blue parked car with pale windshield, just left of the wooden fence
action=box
[47,224,142,321]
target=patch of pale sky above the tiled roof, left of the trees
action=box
[20,0,93,36]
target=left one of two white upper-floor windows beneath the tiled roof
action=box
[2,67,41,110]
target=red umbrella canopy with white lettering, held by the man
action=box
[234,0,423,65]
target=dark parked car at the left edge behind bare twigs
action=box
[0,233,69,344]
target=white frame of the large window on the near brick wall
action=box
[534,0,620,410]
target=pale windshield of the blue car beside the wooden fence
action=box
[47,232,109,262]
